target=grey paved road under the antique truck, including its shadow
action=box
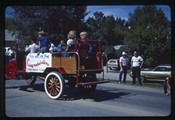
[5,80,171,117]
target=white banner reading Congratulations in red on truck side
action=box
[26,53,52,73]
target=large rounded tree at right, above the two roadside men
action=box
[124,5,171,67]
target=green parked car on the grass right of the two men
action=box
[129,64,171,82]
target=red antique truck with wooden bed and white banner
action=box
[5,40,109,99]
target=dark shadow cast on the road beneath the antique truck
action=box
[19,83,131,102]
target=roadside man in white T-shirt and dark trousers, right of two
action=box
[131,51,143,85]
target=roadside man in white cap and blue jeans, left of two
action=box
[119,51,129,84]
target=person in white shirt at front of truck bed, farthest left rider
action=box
[25,38,39,53]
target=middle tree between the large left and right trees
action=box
[86,12,121,54]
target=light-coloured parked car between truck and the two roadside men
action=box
[107,59,119,70]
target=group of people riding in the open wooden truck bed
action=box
[25,30,92,57]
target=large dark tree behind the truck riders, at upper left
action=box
[7,6,87,46]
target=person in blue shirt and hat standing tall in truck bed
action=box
[38,31,49,53]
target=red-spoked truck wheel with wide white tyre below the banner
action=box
[44,72,65,99]
